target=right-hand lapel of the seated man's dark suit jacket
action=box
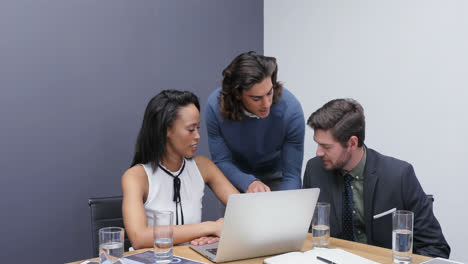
[364,148,379,244]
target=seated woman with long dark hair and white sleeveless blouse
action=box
[122,90,238,249]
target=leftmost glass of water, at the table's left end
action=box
[99,227,125,264]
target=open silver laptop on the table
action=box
[190,188,320,262]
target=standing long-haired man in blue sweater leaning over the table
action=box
[206,51,305,192]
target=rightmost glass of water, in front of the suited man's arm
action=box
[392,210,414,264]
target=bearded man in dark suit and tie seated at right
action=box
[303,99,450,258]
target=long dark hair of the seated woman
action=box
[130,90,200,170]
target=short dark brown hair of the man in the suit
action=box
[307,99,366,147]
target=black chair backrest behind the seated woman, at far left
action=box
[88,196,131,257]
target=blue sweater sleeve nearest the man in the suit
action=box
[280,100,305,190]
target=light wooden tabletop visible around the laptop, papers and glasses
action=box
[69,233,431,264]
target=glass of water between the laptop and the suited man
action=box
[312,203,330,247]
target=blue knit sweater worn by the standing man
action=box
[206,88,305,192]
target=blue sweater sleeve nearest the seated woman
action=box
[205,98,257,192]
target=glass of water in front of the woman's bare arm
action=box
[153,211,174,264]
